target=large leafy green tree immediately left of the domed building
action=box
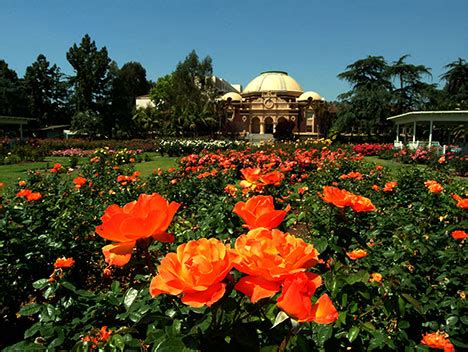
[150,51,217,135]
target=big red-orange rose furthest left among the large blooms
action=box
[96,193,180,266]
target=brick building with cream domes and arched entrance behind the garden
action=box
[220,71,324,137]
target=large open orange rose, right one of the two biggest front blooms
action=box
[234,228,318,302]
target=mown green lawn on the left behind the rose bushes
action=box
[0,153,177,185]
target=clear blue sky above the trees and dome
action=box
[0,0,468,100]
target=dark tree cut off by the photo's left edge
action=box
[0,60,28,116]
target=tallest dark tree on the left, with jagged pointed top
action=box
[67,34,111,112]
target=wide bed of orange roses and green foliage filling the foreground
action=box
[0,145,468,351]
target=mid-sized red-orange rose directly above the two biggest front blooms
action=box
[233,196,291,230]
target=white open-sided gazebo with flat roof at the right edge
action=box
[387,110,468,146]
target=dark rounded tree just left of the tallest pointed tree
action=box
[24,54,69,126]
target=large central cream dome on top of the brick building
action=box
[242,71,304,96]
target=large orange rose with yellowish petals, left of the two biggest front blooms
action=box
[150,238,234,308]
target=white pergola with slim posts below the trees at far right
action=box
[387,110,468,145]
